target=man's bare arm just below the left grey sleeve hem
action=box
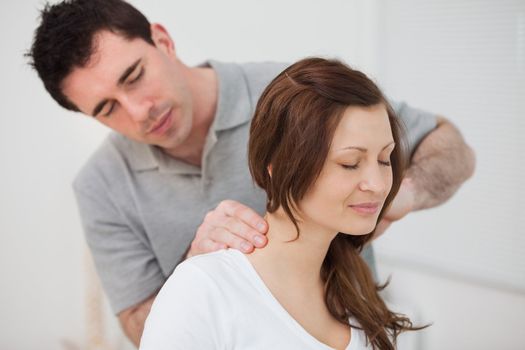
[118,293,157,348]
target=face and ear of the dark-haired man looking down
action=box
[62,25,193,149]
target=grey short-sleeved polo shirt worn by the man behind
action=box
[73,61,435,313]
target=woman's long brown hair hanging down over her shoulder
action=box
[248,58,421,350]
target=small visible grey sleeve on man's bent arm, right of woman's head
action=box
[390,101,437,154]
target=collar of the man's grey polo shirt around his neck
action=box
[131,60,254,175]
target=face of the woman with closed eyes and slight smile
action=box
[299,104,395,235]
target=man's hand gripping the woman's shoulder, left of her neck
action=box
[187,200,268,258]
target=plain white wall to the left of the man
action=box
[0,1,104,350]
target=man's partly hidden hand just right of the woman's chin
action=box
[374,177,415,238]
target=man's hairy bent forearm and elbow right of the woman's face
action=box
[406,117,475,210]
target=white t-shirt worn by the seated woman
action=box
[140,249,372,350]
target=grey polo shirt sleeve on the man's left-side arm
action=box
[73,167,166,314]
